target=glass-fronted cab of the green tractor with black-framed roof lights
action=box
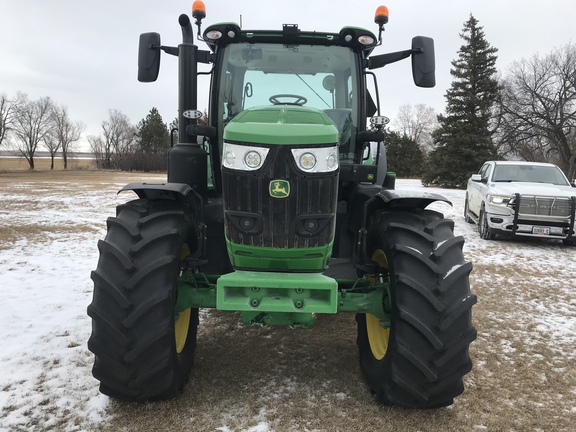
[203,24,376,167]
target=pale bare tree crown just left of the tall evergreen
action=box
[393,104,438,153]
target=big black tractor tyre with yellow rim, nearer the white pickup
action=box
[356,209,476,408]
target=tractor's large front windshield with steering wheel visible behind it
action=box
[218,43,358,161]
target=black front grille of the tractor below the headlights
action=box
[222,146,338,248]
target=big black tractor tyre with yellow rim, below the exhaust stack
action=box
[88,199,198,402]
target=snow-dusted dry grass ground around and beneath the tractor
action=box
[0,170,576,432]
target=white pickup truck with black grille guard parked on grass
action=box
[464,161,576,245]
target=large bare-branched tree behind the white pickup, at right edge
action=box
[497,44,576,178]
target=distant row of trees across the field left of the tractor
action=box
[0,92,177,171]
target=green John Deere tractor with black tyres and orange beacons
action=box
[88,1,476,408]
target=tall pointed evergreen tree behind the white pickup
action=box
[422,15,499,187]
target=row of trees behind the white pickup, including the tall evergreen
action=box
[387,15,576,188]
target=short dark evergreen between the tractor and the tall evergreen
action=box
[386,131,424,178]
